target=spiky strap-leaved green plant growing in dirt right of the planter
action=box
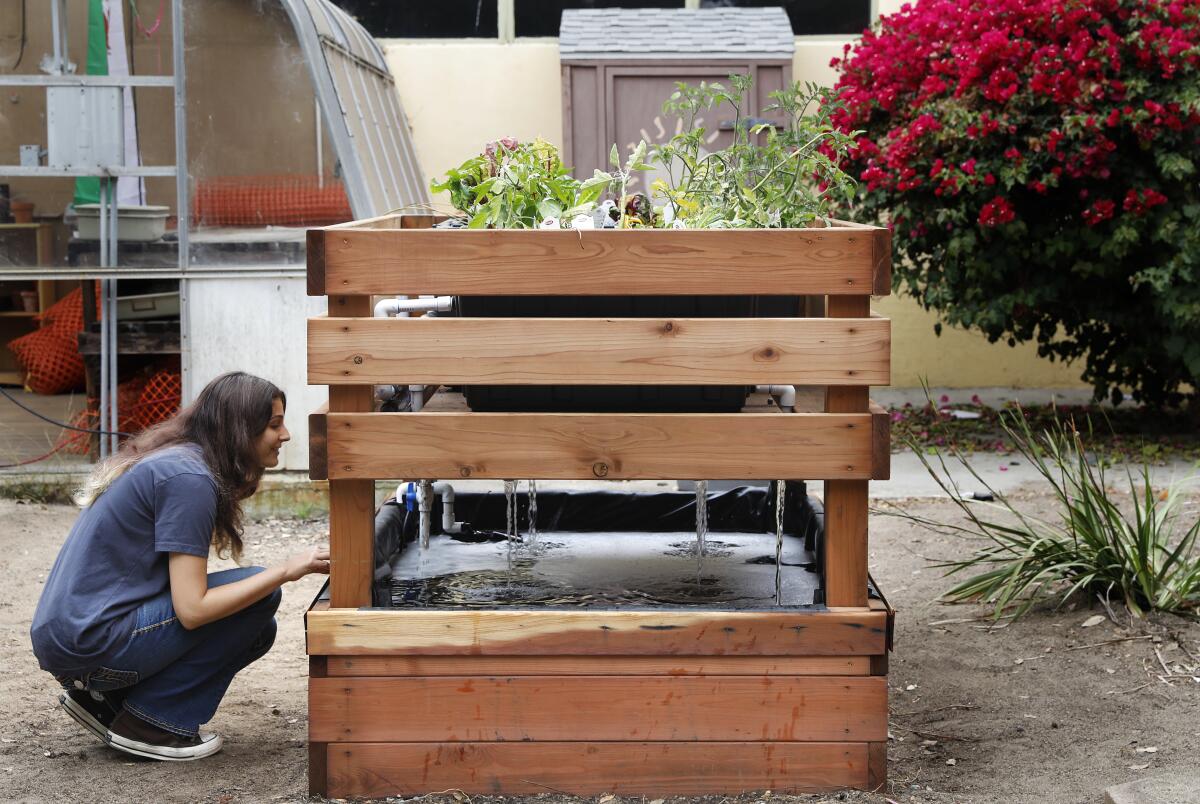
[902,408,1200,617]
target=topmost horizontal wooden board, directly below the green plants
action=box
[325,228,877,295]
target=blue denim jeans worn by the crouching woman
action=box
[60,566,282,737]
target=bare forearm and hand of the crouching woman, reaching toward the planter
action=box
[168,547,329,631]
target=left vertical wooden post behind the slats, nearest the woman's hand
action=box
[329,296,374,608]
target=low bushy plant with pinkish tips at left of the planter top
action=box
[431,137,613,229]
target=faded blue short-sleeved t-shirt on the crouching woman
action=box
[30,444,217,674]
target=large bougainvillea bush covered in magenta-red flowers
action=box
[834,0,1200,404]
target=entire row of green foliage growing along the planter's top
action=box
[431,76,853,229]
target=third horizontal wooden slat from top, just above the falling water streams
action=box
[328,412,872,480]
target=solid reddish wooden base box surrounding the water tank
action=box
[306,601,889,798]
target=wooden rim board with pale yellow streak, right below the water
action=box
[307,608,887,656]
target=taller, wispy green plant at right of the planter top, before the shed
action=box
[652,74,857,228]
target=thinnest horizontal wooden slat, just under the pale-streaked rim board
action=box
[320,656,875,677]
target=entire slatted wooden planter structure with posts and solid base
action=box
[306,216,890,798]
